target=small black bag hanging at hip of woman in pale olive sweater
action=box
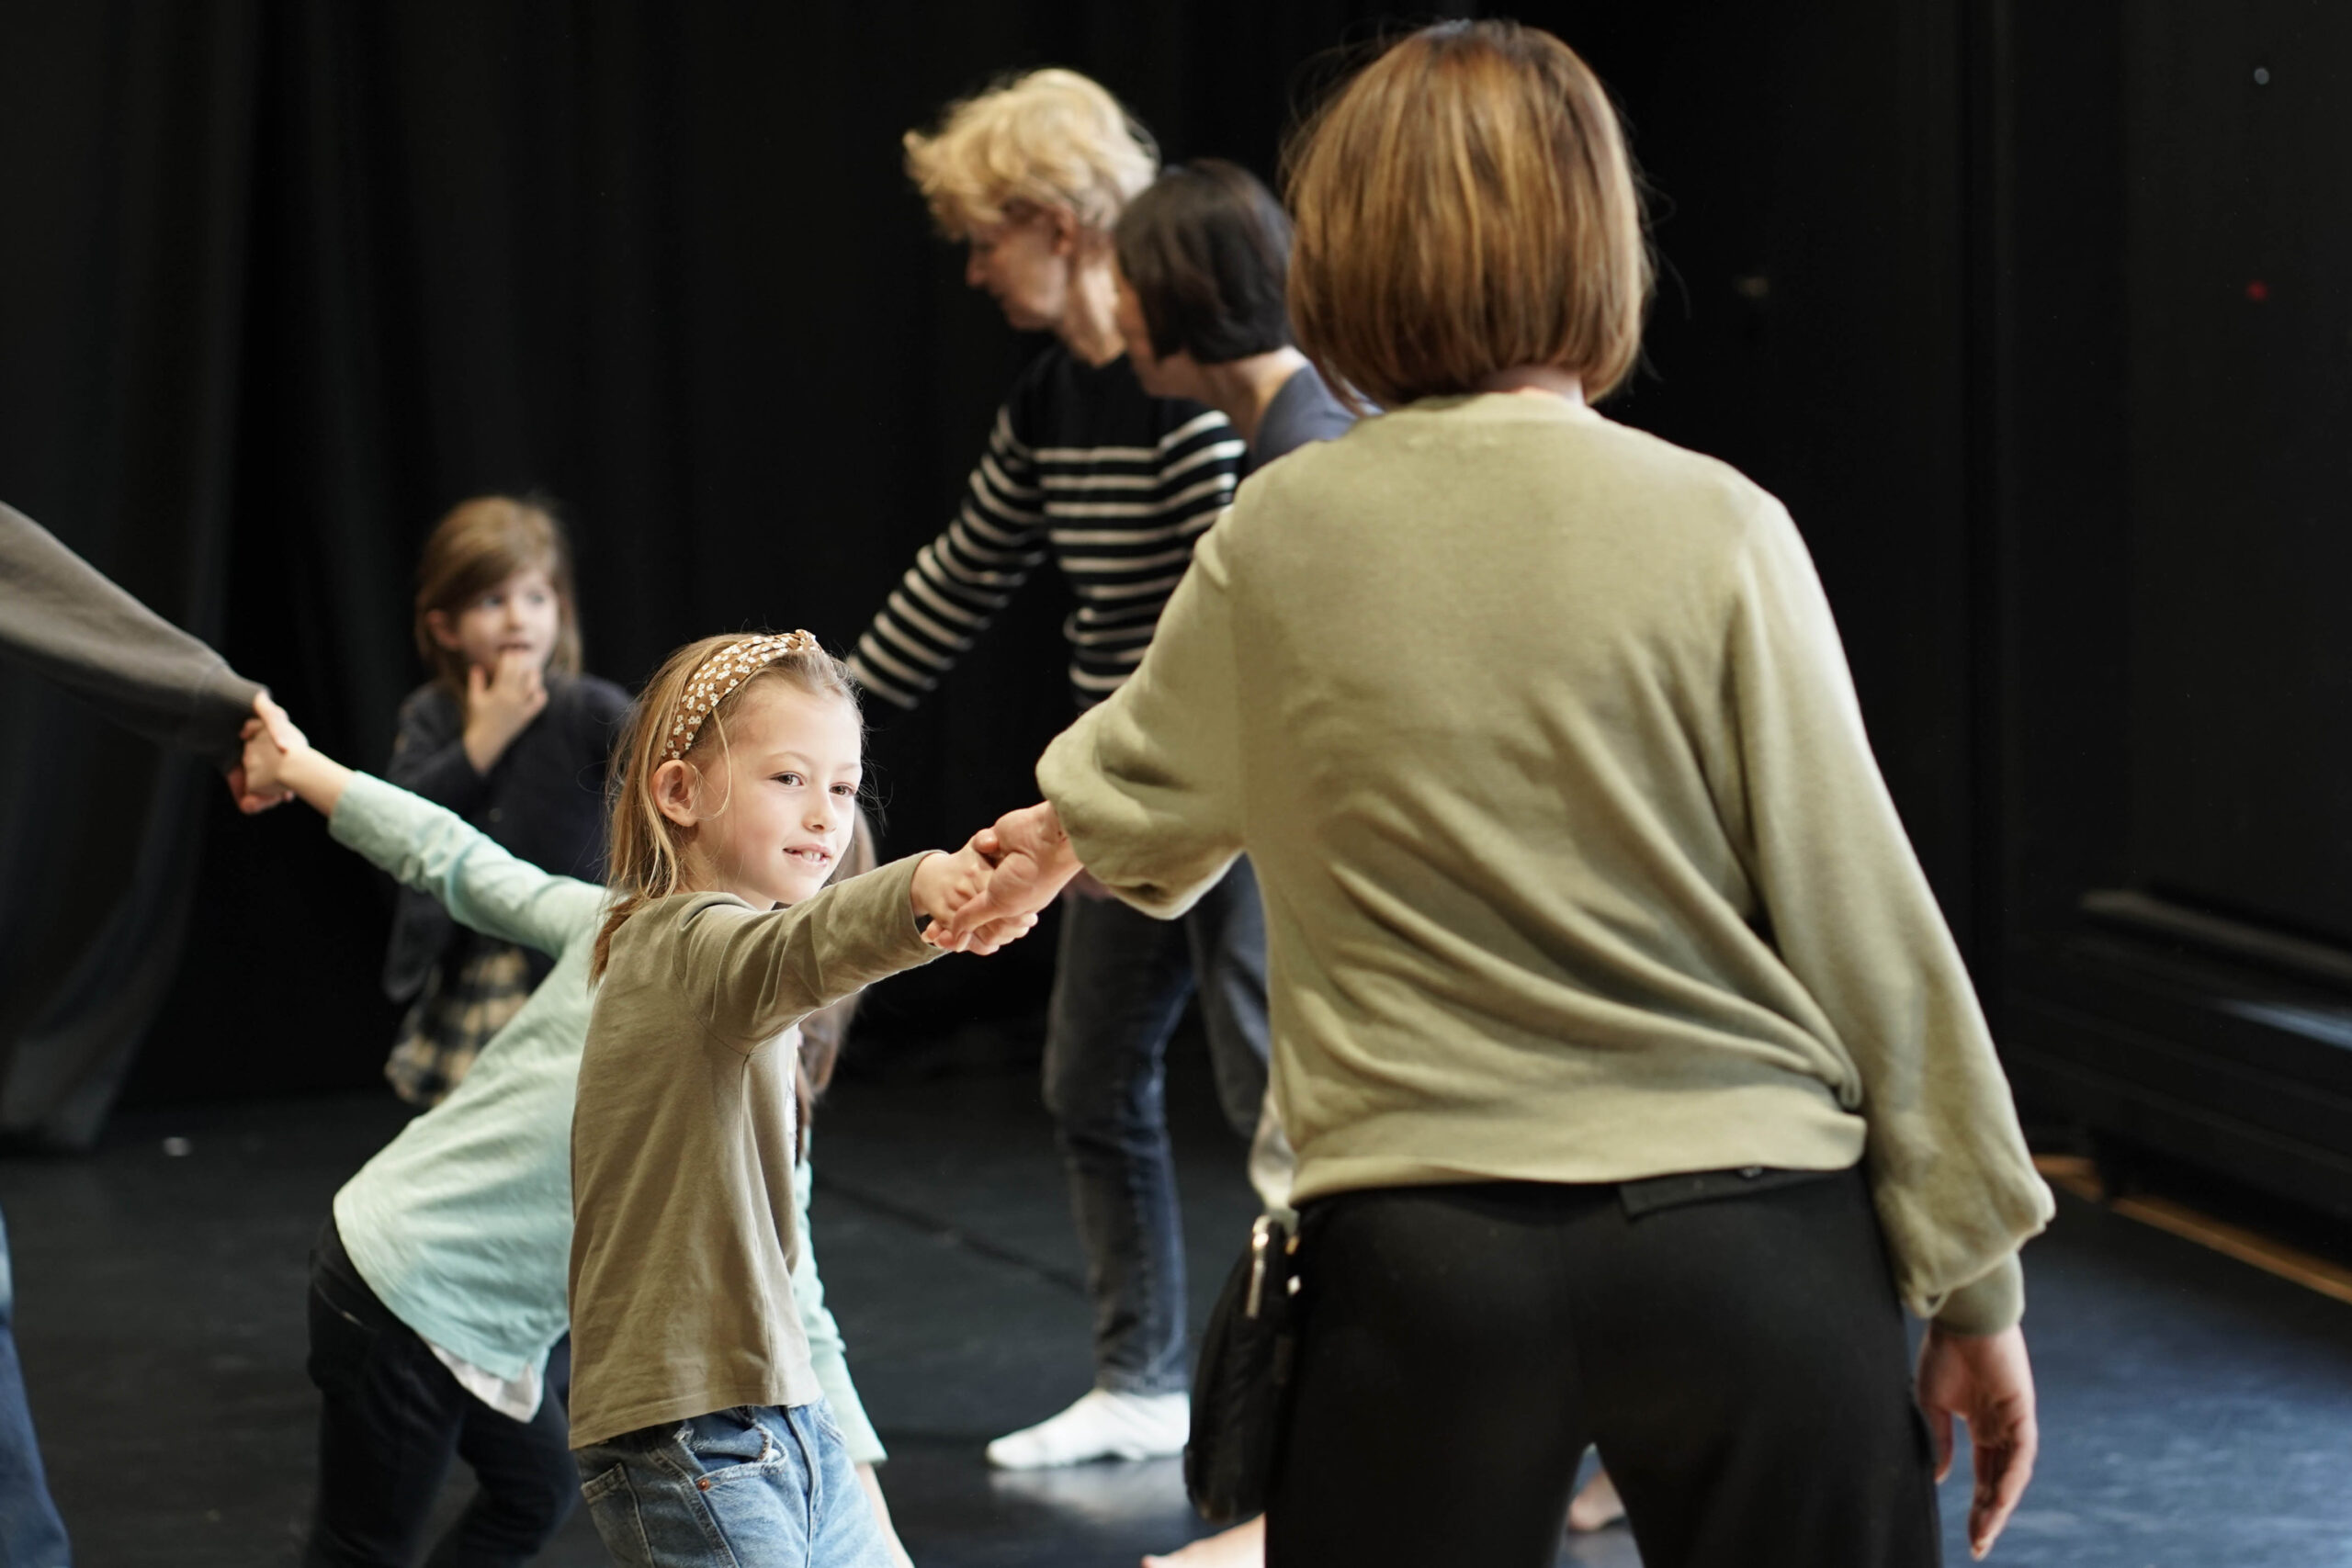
[1183,1215,1298,1523]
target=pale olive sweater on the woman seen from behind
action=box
[1037,395,2051,1333]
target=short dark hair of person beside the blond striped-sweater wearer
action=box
[1113,157,1291,365]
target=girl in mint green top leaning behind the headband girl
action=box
[243,696,906,1568]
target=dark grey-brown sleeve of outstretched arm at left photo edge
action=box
[0,493,261,766]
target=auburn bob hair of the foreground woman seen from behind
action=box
[1284,21,1651,407]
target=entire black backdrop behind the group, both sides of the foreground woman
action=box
[0,0,2135,1140]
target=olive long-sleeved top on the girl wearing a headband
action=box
[564,856,941,1448]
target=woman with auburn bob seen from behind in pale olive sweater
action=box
[950,21,2051,1568]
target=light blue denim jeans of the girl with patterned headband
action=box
[571,1401,891,1568]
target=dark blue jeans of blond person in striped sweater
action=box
[1045,861,1265,1394]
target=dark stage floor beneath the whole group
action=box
[0,1048,2352,1568]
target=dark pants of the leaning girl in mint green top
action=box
[303,1220,581,1568]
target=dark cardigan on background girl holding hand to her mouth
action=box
[383,674,628,1001]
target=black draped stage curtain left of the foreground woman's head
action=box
[0,0,1486,1128]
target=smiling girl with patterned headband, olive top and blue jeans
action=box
[571,632,1035,1568]
